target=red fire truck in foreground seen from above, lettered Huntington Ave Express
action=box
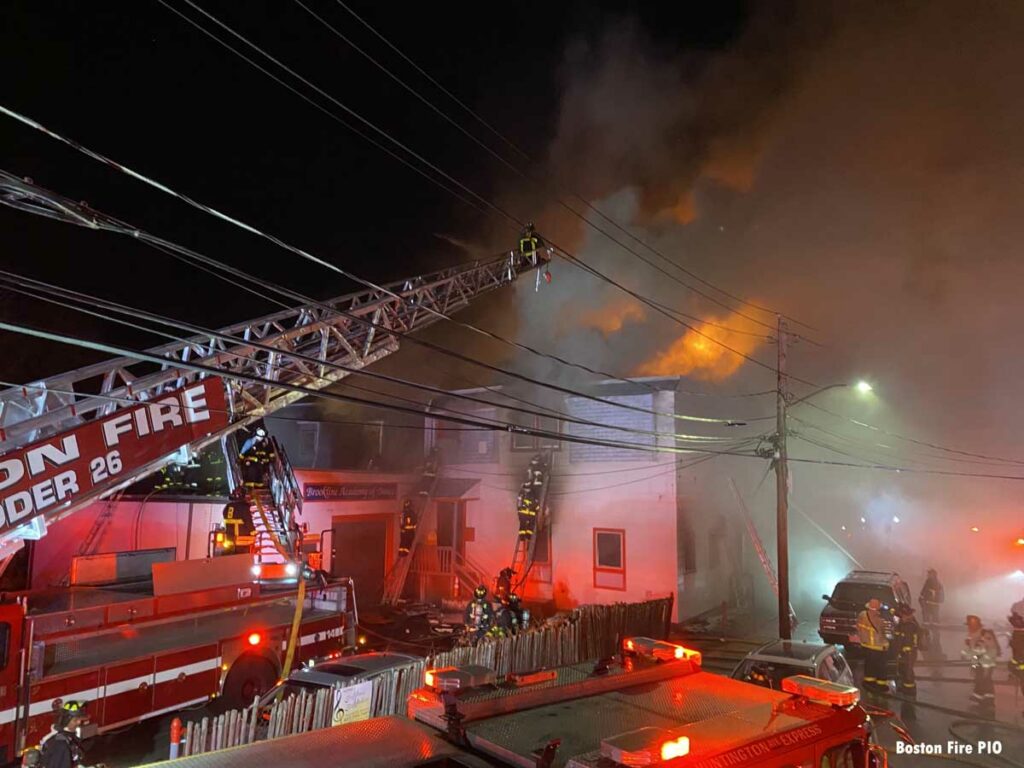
[144,637,888,768]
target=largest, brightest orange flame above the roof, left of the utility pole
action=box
[636,314,764,381]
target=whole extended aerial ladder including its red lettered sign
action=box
[0,171,550,566]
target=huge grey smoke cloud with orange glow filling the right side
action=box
[493,2,1024,616]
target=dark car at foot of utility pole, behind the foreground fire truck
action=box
[732,640,855,690]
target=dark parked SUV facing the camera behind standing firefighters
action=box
[818,570,911,648]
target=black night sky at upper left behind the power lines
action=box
[0,0,744,380]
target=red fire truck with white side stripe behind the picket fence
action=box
[0,555,357,764]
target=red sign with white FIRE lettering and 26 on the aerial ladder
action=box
[0,378,229,531]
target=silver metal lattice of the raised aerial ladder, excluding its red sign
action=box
[0,173,544,564]
